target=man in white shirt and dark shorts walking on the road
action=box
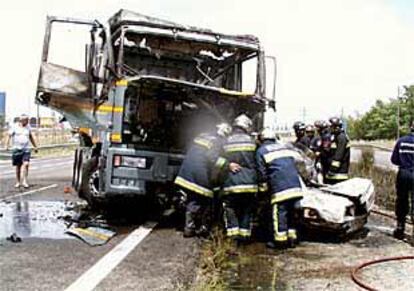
[6,114,37,188]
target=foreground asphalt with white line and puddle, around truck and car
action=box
[0,154,414,290]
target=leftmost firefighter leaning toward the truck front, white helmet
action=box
[174,123,231,237]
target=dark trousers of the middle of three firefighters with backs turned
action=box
[222,193,255,240]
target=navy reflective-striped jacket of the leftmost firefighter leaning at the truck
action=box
[174,134,226,197]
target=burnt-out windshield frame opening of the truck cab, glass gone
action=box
[112,25,265,98]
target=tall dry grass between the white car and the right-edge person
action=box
[351,148,397,210]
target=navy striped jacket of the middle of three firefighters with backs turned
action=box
[222,128,258,195]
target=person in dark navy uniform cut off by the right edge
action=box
[391,122,414,239]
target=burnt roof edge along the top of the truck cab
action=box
[109,9,260,51]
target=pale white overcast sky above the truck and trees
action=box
[0,0,414,124]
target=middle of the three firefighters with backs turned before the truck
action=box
[221,114,258,242]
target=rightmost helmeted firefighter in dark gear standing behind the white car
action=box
[325,117,351,184]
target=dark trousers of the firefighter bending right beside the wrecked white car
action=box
[272,199,297,242]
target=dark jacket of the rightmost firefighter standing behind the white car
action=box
[326,131,351,181]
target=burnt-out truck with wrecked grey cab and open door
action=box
[36,10,276,204]
